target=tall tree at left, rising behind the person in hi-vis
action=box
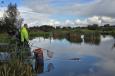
[3,3,22,35]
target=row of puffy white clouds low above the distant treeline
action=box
[42,16,115,27]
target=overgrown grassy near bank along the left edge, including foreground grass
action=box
[0,33,35,76]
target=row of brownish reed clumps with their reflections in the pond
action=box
[53,33,101,45]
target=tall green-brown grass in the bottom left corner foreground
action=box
[0,59,34,76]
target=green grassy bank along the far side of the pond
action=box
[30,29,115,38]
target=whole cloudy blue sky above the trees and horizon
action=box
[0,0,115,27]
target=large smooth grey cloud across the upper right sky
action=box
[60,0,115,17]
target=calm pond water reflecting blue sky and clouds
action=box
[30,35,115,76]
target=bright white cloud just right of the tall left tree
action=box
[19,7,49,27]
